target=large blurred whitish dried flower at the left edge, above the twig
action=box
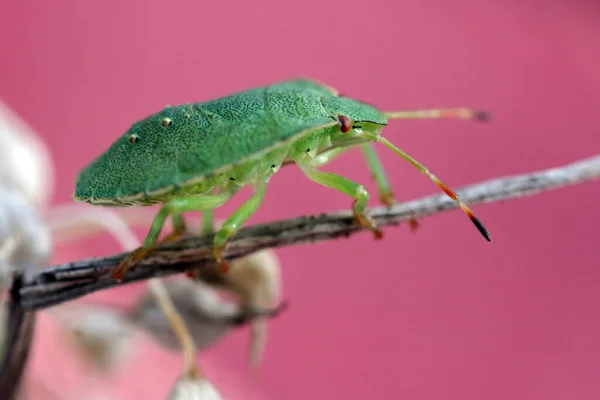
[0,100,53,286]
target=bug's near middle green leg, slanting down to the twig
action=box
[213,181,267,273]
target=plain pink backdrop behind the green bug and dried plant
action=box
[0,0,600,400]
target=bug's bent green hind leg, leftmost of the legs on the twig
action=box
[113,191,233,282]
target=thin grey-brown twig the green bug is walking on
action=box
[10,155,600,310]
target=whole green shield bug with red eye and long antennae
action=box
[73,79,491,281]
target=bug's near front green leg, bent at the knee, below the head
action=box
[298,164,383,239]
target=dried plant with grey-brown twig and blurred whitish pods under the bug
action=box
[0,97,600,399]
